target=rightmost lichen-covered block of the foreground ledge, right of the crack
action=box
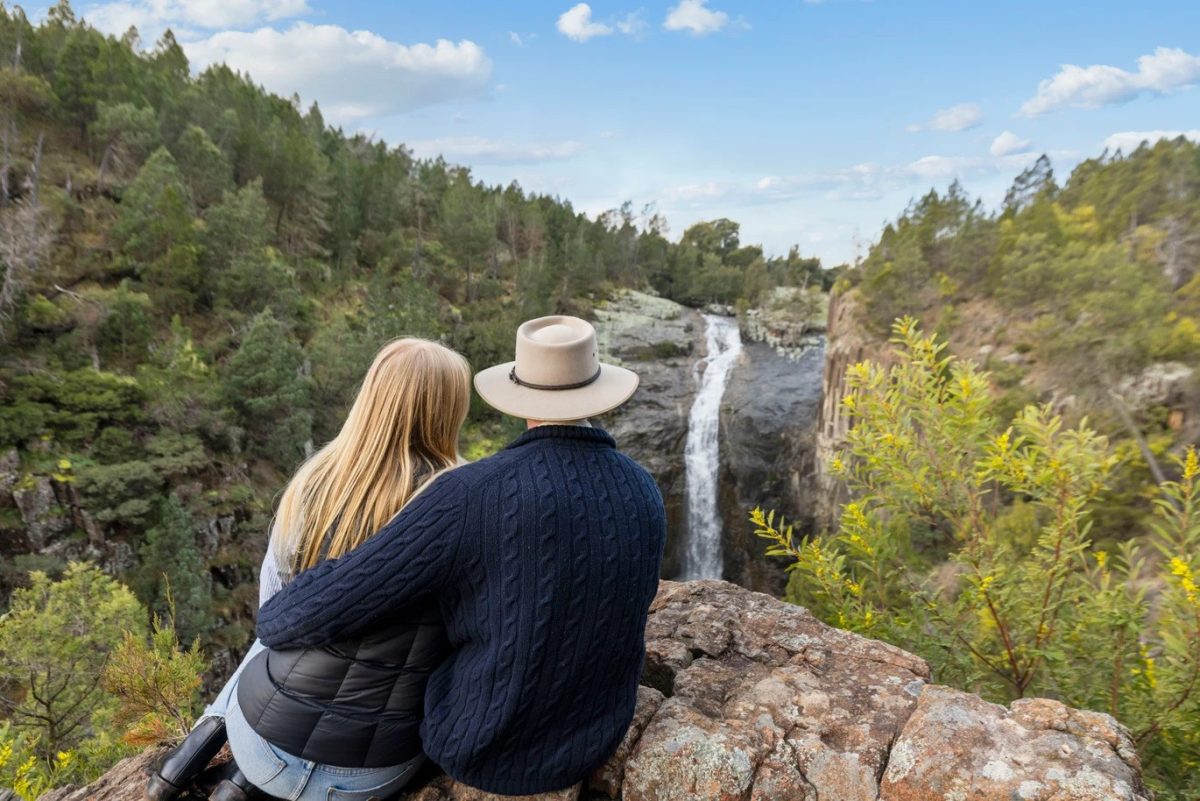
[880,687,1151,801]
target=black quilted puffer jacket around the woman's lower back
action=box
[238,604,450,767]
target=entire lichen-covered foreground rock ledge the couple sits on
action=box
[32,582,1150,801]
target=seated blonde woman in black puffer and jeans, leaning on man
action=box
[146,338,470,801]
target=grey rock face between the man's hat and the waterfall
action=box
[595,291,704,576]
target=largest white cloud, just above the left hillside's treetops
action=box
[184,22,492,122]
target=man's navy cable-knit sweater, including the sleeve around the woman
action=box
[258,426,666,795]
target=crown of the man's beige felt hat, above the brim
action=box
[514,314,600,389]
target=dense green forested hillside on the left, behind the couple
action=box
[0,2,824,795]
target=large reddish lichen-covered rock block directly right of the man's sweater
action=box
[623,582,929,801]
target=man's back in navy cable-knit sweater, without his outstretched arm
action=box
[422,426,665,794]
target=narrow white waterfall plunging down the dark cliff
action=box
[682,314,742,579]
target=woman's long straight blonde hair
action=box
[272,337,470,573]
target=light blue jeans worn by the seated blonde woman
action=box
[203,640,425,801]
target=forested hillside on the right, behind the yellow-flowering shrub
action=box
[842,138,1200,541]
